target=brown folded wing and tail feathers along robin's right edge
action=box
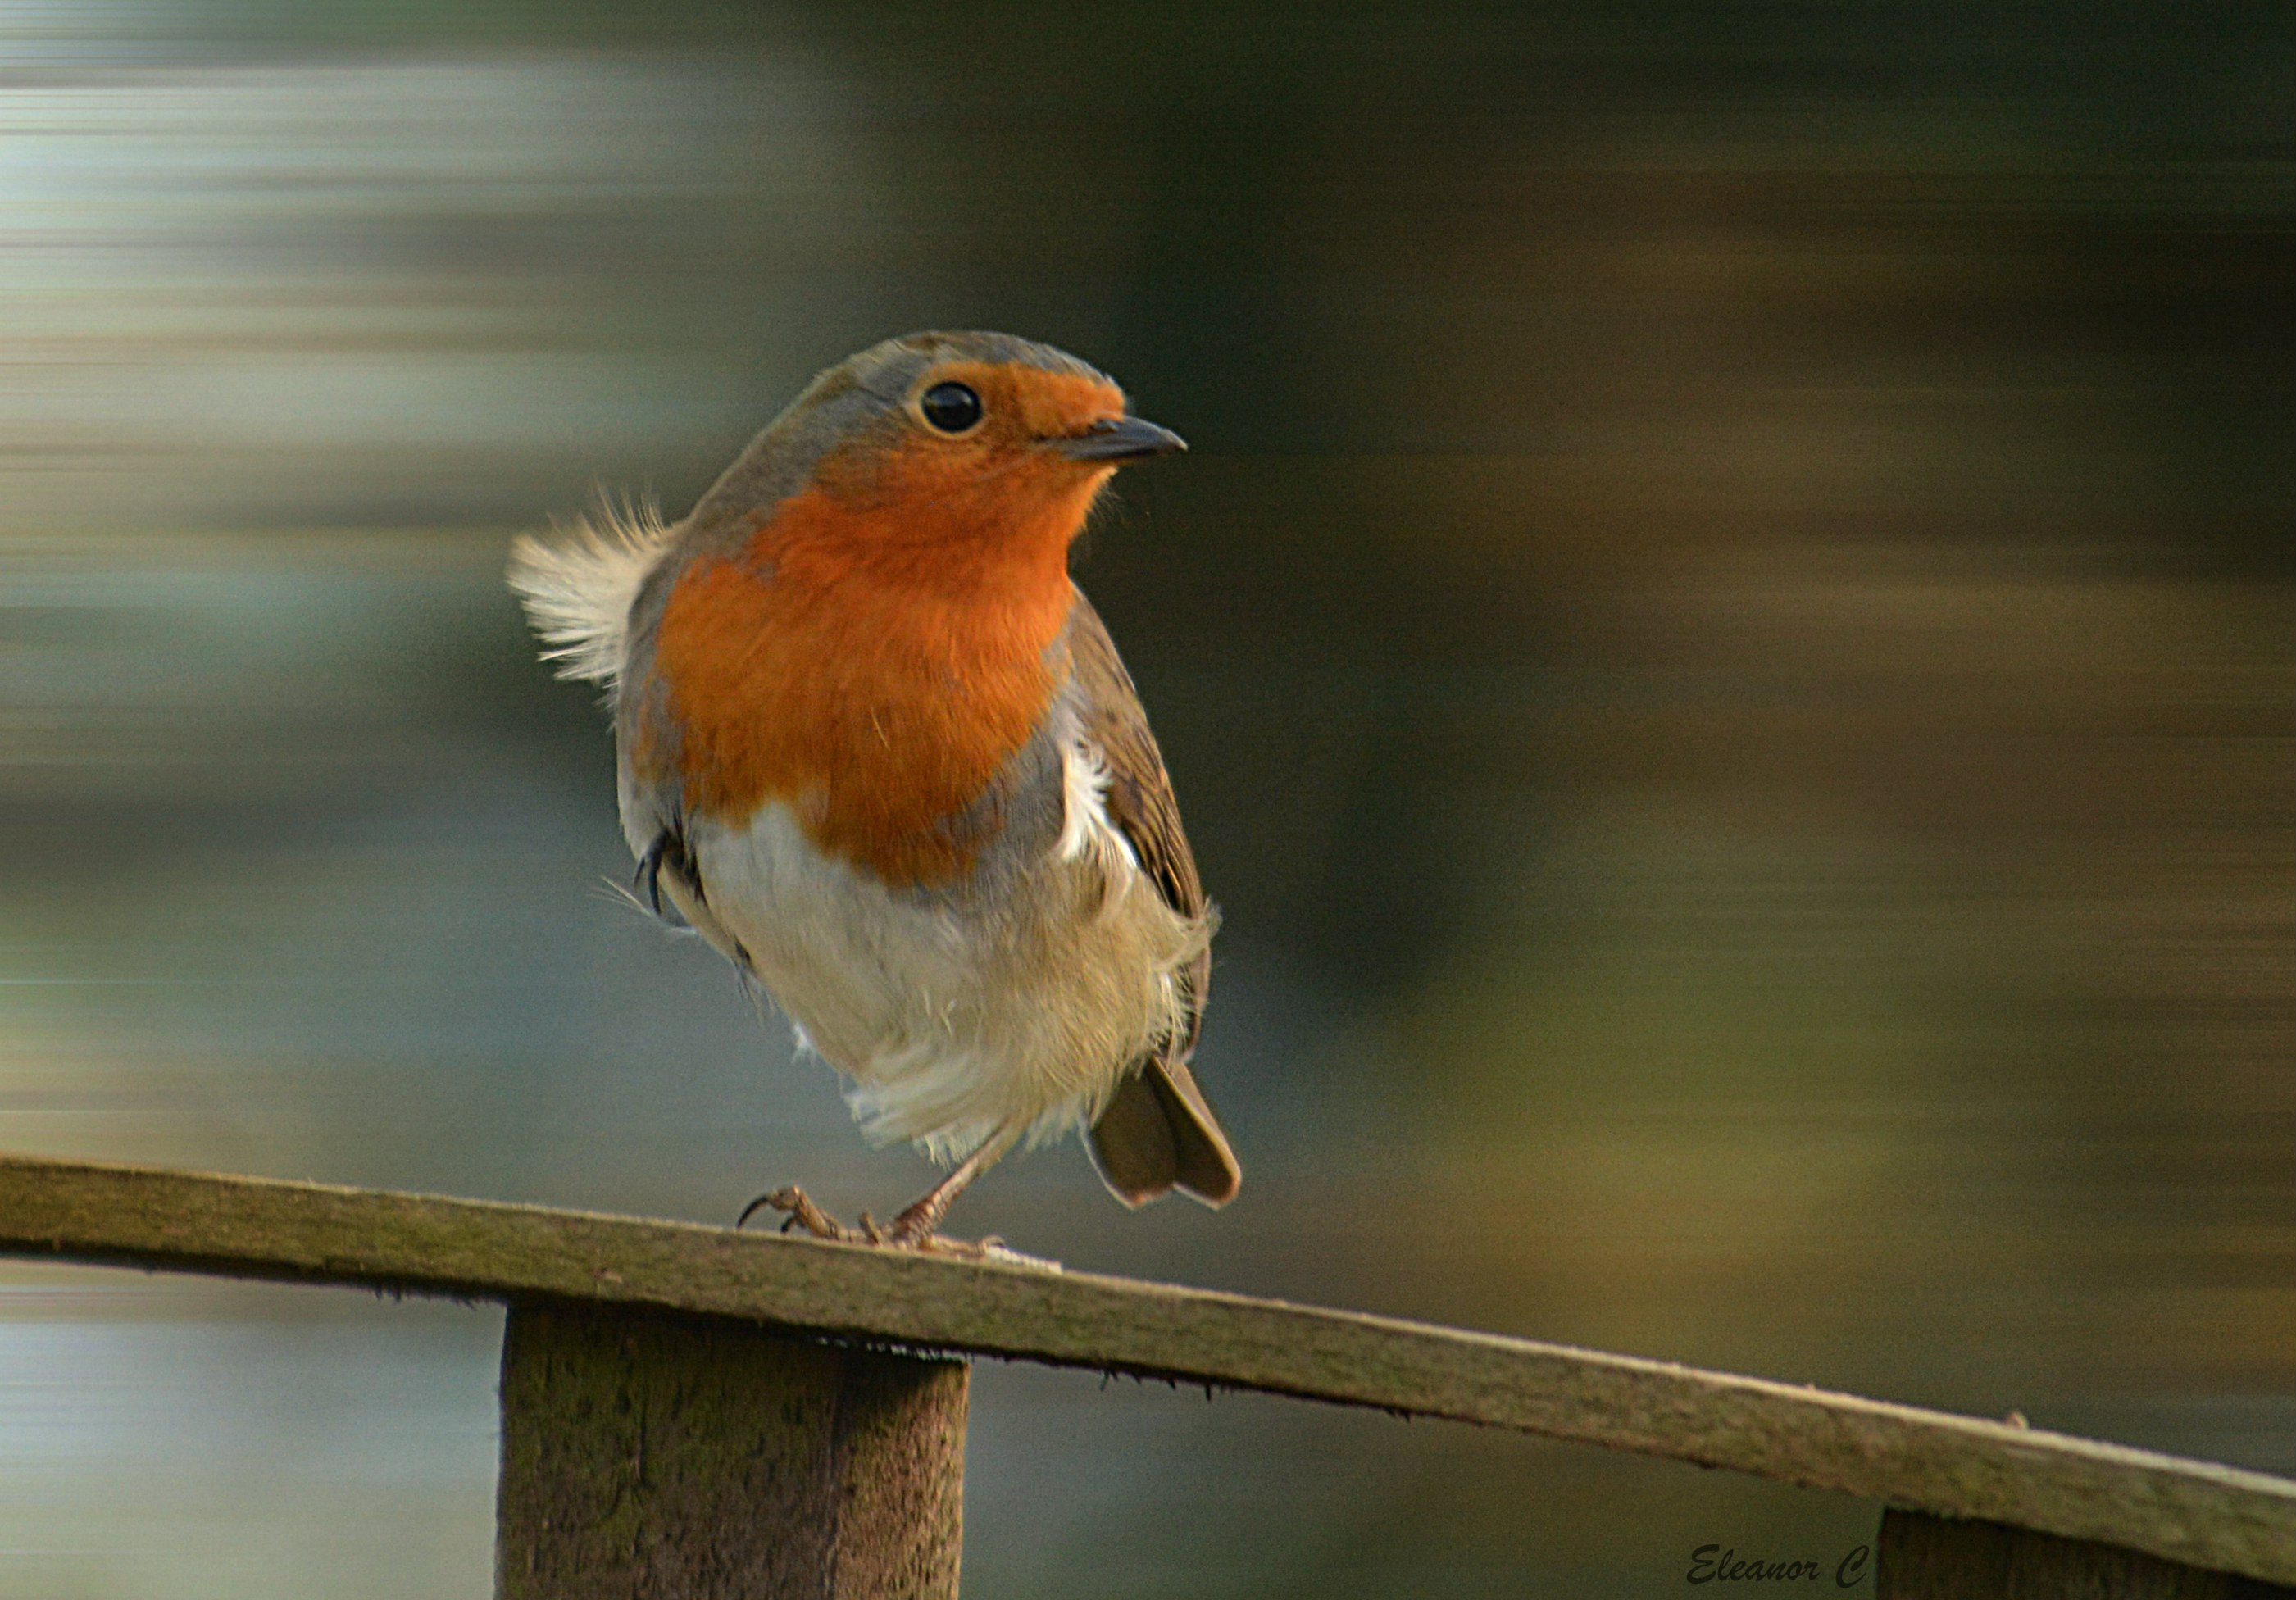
[1067,590,1244,1205]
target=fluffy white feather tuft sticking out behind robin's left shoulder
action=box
[510,501,675,689]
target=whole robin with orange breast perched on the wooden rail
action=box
[510,333,1242,1253]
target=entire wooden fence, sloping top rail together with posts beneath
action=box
[0,1157,2296,1600]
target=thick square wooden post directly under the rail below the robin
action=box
[493,1302,966,1600]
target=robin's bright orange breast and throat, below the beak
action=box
[640,454,1107,884]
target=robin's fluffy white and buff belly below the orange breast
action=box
[670,751,1212,1161]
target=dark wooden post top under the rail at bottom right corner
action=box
[1874,1508,2296,1600]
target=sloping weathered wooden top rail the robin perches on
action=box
[0,1159,2296,1584]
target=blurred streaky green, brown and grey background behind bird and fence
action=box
[0,0,2296,1598]
